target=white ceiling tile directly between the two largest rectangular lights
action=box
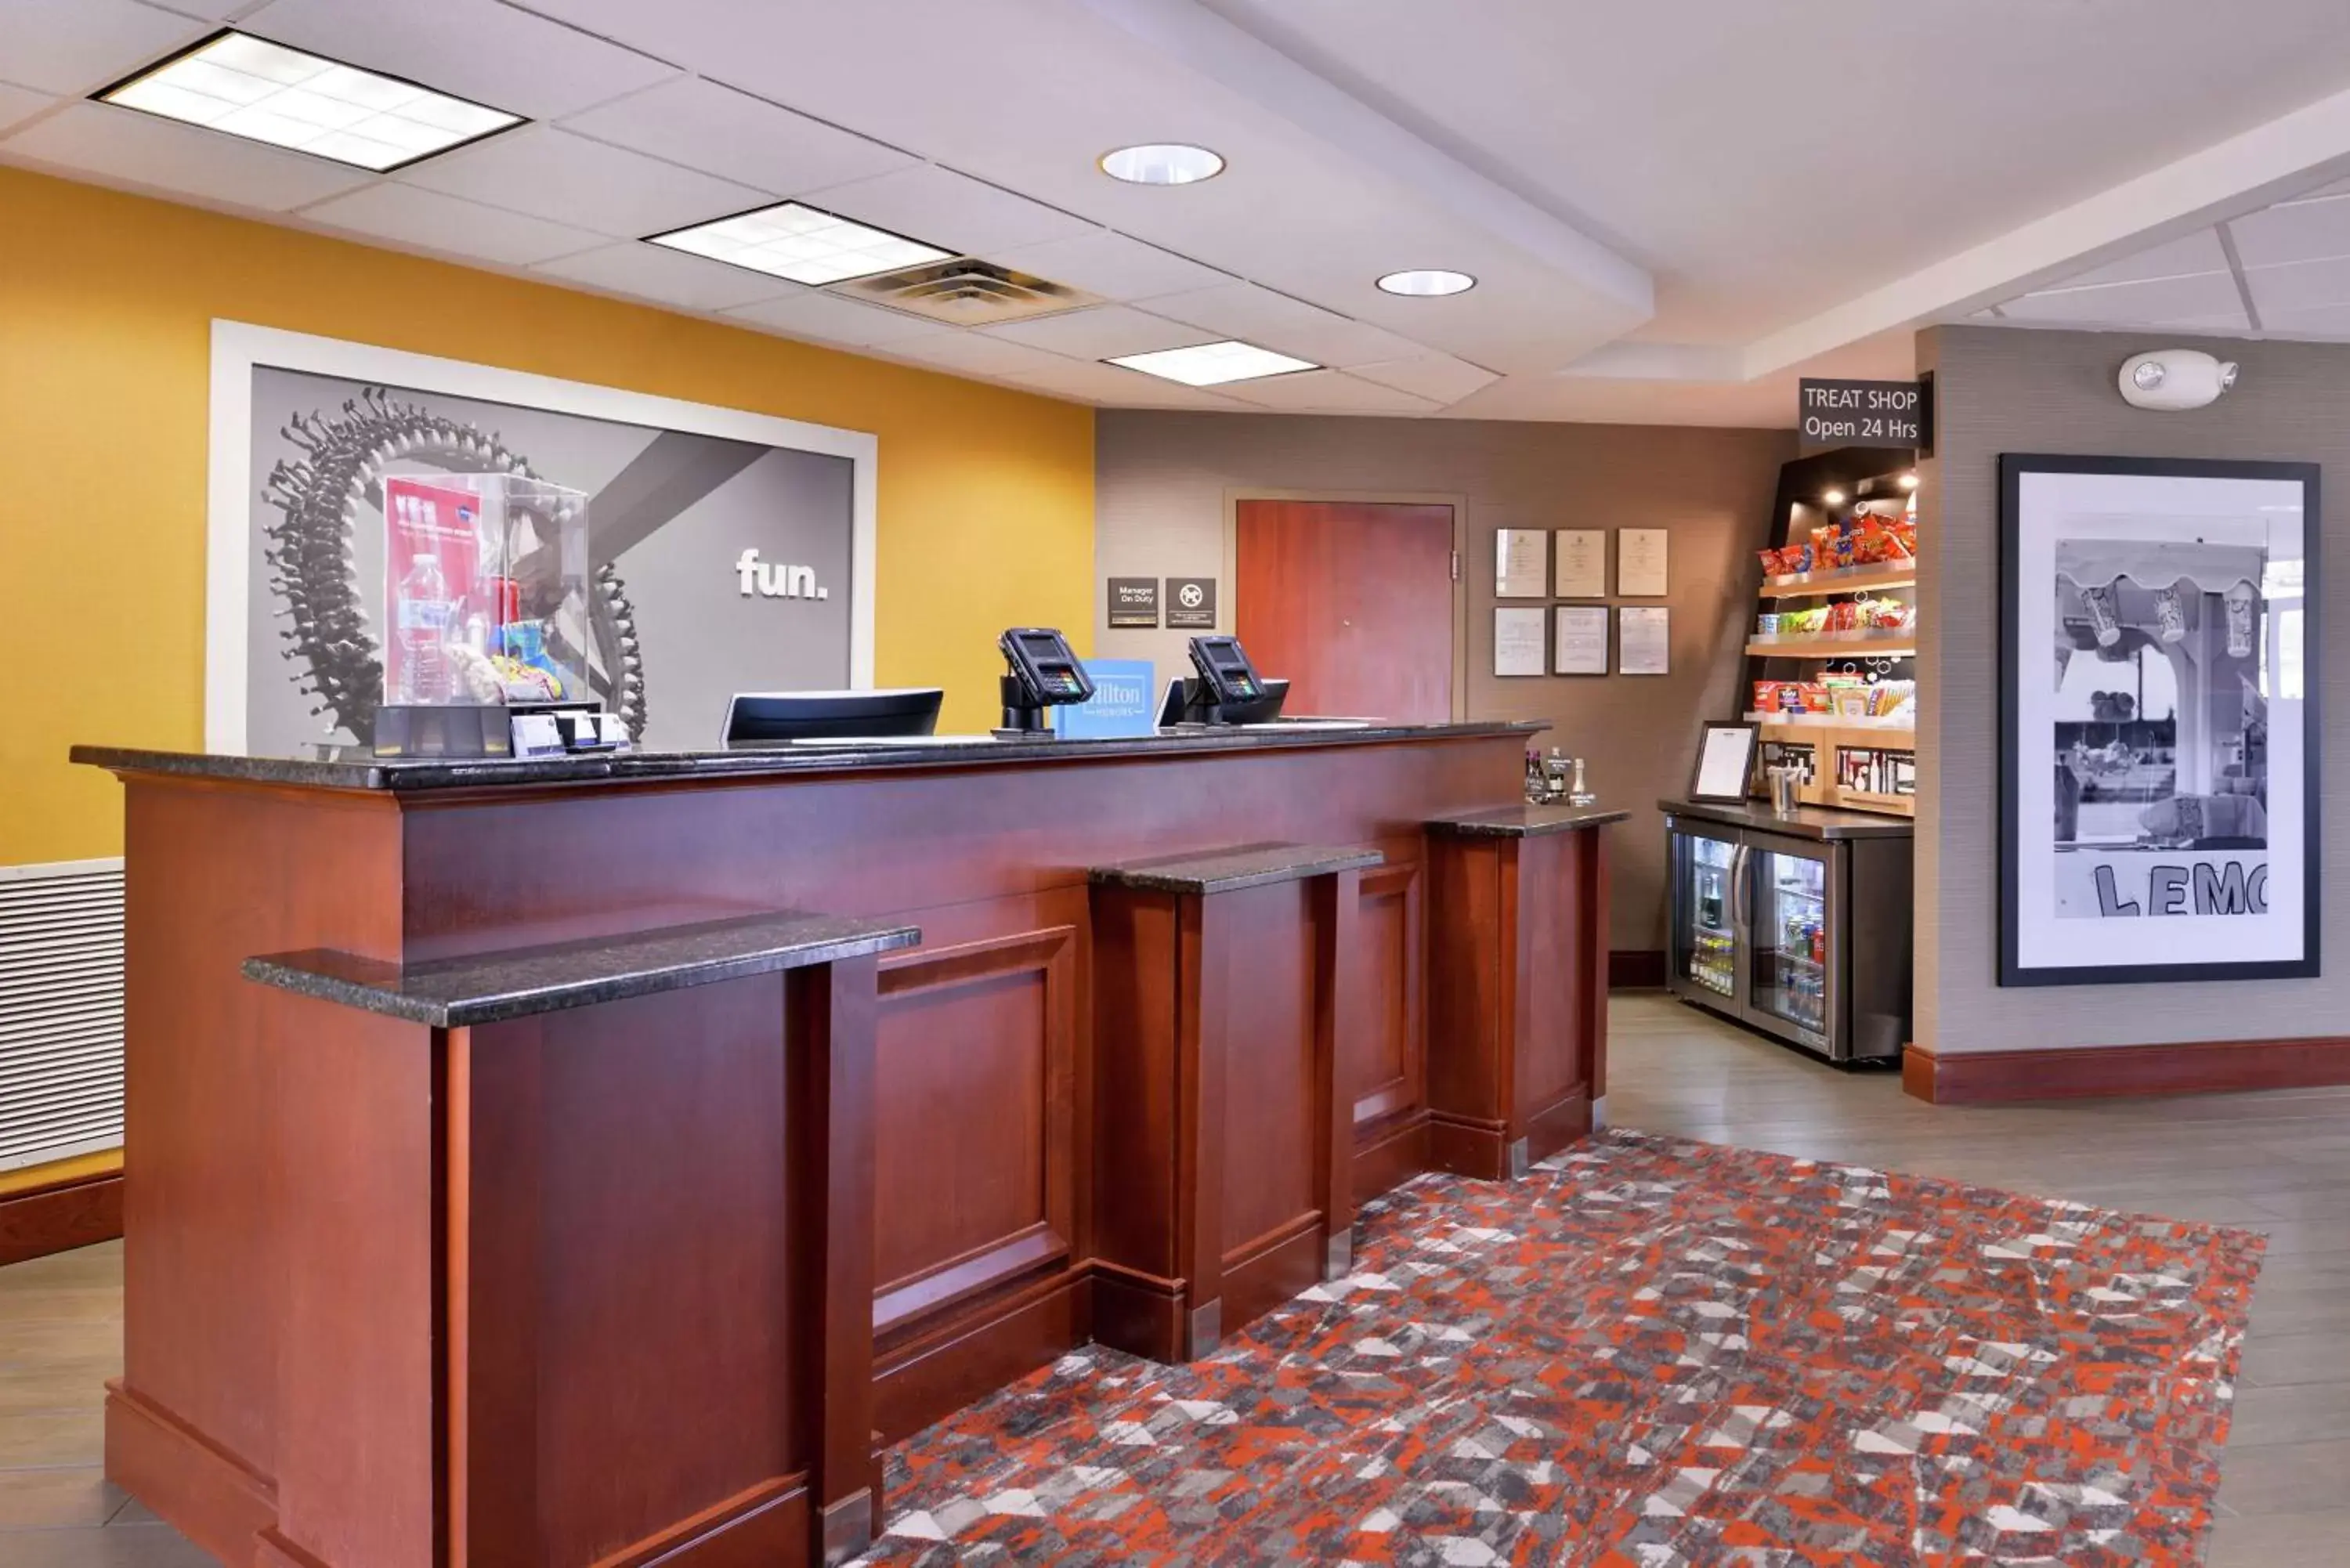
[400,125,771,240]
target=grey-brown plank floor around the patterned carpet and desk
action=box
[0,997,2350,1568]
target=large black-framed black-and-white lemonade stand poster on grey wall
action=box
[2000,453,2319,985]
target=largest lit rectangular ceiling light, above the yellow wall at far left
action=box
[94,31,522,174]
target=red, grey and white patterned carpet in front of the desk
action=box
[867,1131,2263,1568]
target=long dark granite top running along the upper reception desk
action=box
[73,721,1546,793]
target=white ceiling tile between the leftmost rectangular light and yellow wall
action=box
[0,101,374,211]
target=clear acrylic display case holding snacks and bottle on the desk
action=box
[376,475,595,754]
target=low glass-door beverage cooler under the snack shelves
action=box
[1666,802,1911,1063]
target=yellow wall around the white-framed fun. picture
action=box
[0,169,1093,865]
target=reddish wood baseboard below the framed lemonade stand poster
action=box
[1901,1037,2350,1105]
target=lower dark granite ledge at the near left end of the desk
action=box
[244,915,921,1030]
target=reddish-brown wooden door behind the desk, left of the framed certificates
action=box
[1234,500,1452,724]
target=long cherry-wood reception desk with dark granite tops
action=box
[75,724,1607,1568]
